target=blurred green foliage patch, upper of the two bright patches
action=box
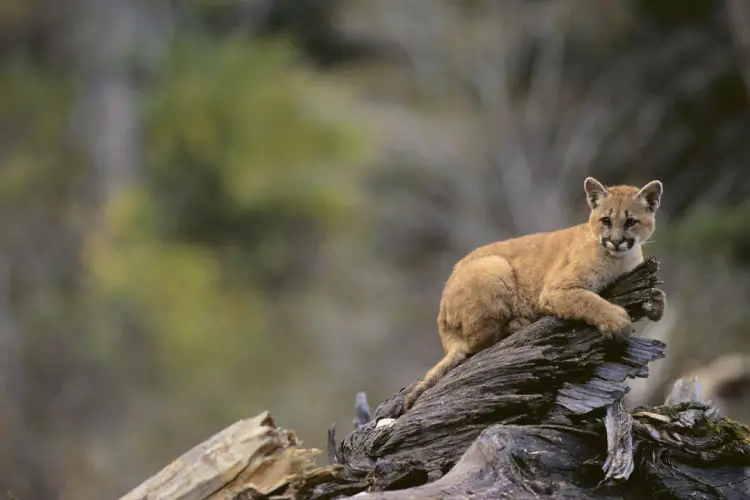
[147,38,361,223]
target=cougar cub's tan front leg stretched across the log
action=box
[541,287,633,339]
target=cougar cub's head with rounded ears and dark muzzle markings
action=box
[584,177,662,256]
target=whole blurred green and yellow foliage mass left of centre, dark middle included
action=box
[83,38,367,418]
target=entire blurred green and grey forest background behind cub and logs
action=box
[0,0,750,500]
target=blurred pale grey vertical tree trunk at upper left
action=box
[69,0,171,203]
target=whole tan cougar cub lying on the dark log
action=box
[404,177,666,410]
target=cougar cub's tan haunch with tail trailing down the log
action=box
[404,256,515,411]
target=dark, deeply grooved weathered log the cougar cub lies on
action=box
[329,259,665,488]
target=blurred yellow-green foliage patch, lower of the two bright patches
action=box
[84,191,268,397]
